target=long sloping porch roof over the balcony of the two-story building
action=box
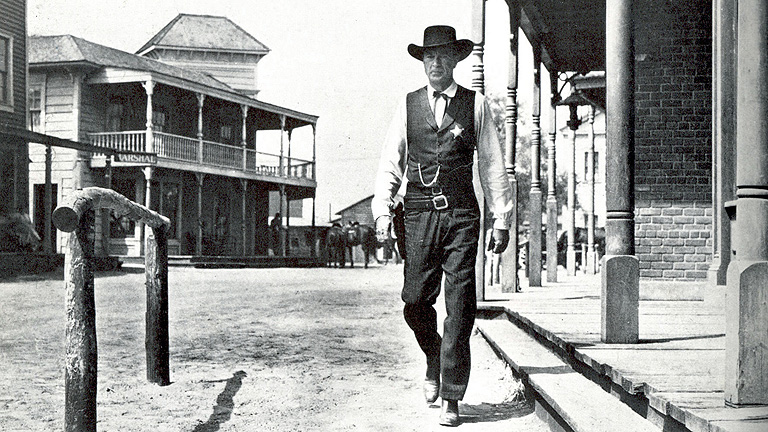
[27,35,318,129]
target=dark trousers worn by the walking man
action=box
[402,207,480,400]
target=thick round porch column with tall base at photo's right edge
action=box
[725,0,768,405]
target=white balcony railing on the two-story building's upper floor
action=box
[89,131,314,179]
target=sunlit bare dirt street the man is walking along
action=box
[0,265,547,432]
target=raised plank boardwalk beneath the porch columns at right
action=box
[478,275,768,432]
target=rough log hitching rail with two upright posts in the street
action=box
[53,187,171,432]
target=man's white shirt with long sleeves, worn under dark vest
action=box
[371,82,513,229]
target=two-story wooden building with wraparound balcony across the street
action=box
[29,15,317,255]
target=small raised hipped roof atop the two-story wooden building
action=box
[136,14,269,55]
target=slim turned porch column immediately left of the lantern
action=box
[547,71,560,282]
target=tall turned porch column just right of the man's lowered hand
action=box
[501,0,520,293]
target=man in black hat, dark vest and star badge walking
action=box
[371,26,513,426]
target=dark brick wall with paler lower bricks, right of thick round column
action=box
[632,0,712,280]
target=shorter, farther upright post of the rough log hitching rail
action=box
[144,226,171,386]
